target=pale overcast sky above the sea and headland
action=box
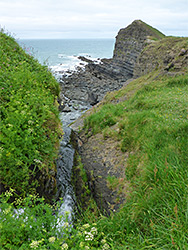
[0,0,188,39]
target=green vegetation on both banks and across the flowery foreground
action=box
[0,28,188,250]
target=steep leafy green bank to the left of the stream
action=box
[0,32,60,193]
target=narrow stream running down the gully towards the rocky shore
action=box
[56,101,90,227]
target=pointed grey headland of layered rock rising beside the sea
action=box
[112,20,164,79]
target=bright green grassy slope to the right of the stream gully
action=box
[85,38,188,249]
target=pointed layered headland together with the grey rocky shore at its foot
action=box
[61,20,164,108]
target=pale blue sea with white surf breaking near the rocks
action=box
[18,39,115,76]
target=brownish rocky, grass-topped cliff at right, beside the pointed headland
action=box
[134,37,188,78]
